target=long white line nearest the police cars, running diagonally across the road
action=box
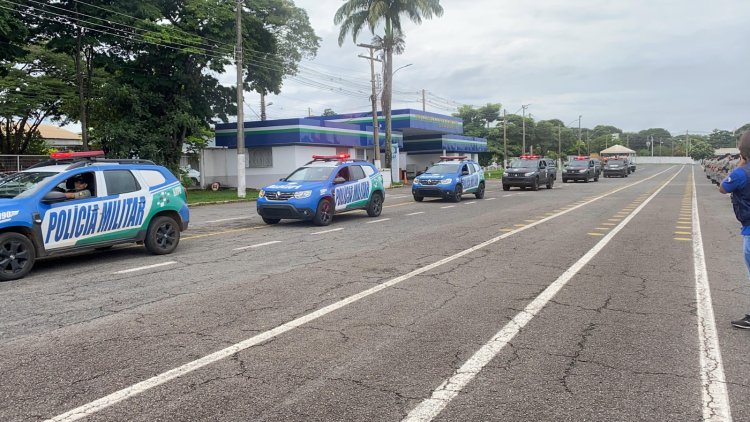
[49,166,674,422]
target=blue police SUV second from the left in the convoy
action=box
[256,154,385,226]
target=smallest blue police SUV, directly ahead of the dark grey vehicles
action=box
[411,156,485,202]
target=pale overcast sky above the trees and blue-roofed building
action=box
[248,0,750,134]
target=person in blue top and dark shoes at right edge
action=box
[719,130,750,330]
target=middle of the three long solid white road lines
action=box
[402,169,682,422]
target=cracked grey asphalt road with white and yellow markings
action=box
[0,165,750,421]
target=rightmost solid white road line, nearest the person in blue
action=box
[692,169,732,422]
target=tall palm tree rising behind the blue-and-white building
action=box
[333,0,443,167]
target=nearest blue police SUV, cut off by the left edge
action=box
[0,151,190,281]
